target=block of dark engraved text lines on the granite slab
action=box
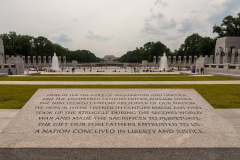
[34,93,205,134]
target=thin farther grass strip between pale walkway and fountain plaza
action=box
[0,75,236,81]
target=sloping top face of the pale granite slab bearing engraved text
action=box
[0,89,240,148]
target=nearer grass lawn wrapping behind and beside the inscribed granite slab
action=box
[0,84,240,109]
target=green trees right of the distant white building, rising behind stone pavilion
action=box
[119,13,240,63]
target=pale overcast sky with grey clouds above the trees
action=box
[0,0,240,57]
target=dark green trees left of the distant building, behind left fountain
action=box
[0,31,101,62]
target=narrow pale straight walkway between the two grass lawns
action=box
[0,80,240,85]
